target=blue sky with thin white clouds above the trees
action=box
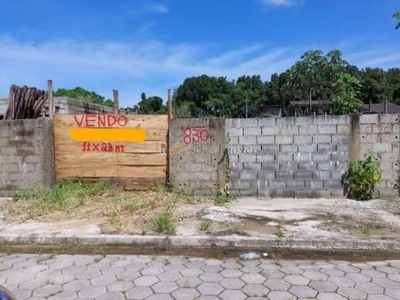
[0,0,400,107]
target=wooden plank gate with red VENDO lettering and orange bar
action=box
[54,115,168,188]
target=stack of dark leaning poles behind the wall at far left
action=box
[6,85,48,120]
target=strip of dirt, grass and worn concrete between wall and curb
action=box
[0,192,400,239]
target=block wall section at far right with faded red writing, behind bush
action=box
[359,114,400,197]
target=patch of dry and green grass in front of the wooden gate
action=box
[0,181,197,234]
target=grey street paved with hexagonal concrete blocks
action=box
[0,254,400,300]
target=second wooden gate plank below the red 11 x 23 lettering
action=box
[56,162,167,179]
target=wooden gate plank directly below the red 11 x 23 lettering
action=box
[55,152,167,167]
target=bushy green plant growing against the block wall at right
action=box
[345,152,382,200]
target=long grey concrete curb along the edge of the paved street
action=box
[0,234,400,253]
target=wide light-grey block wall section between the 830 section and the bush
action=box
[225,116,351,197]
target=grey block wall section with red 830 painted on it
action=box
[169,119,226,195]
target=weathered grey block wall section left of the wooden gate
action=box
[0,118,55,196]
